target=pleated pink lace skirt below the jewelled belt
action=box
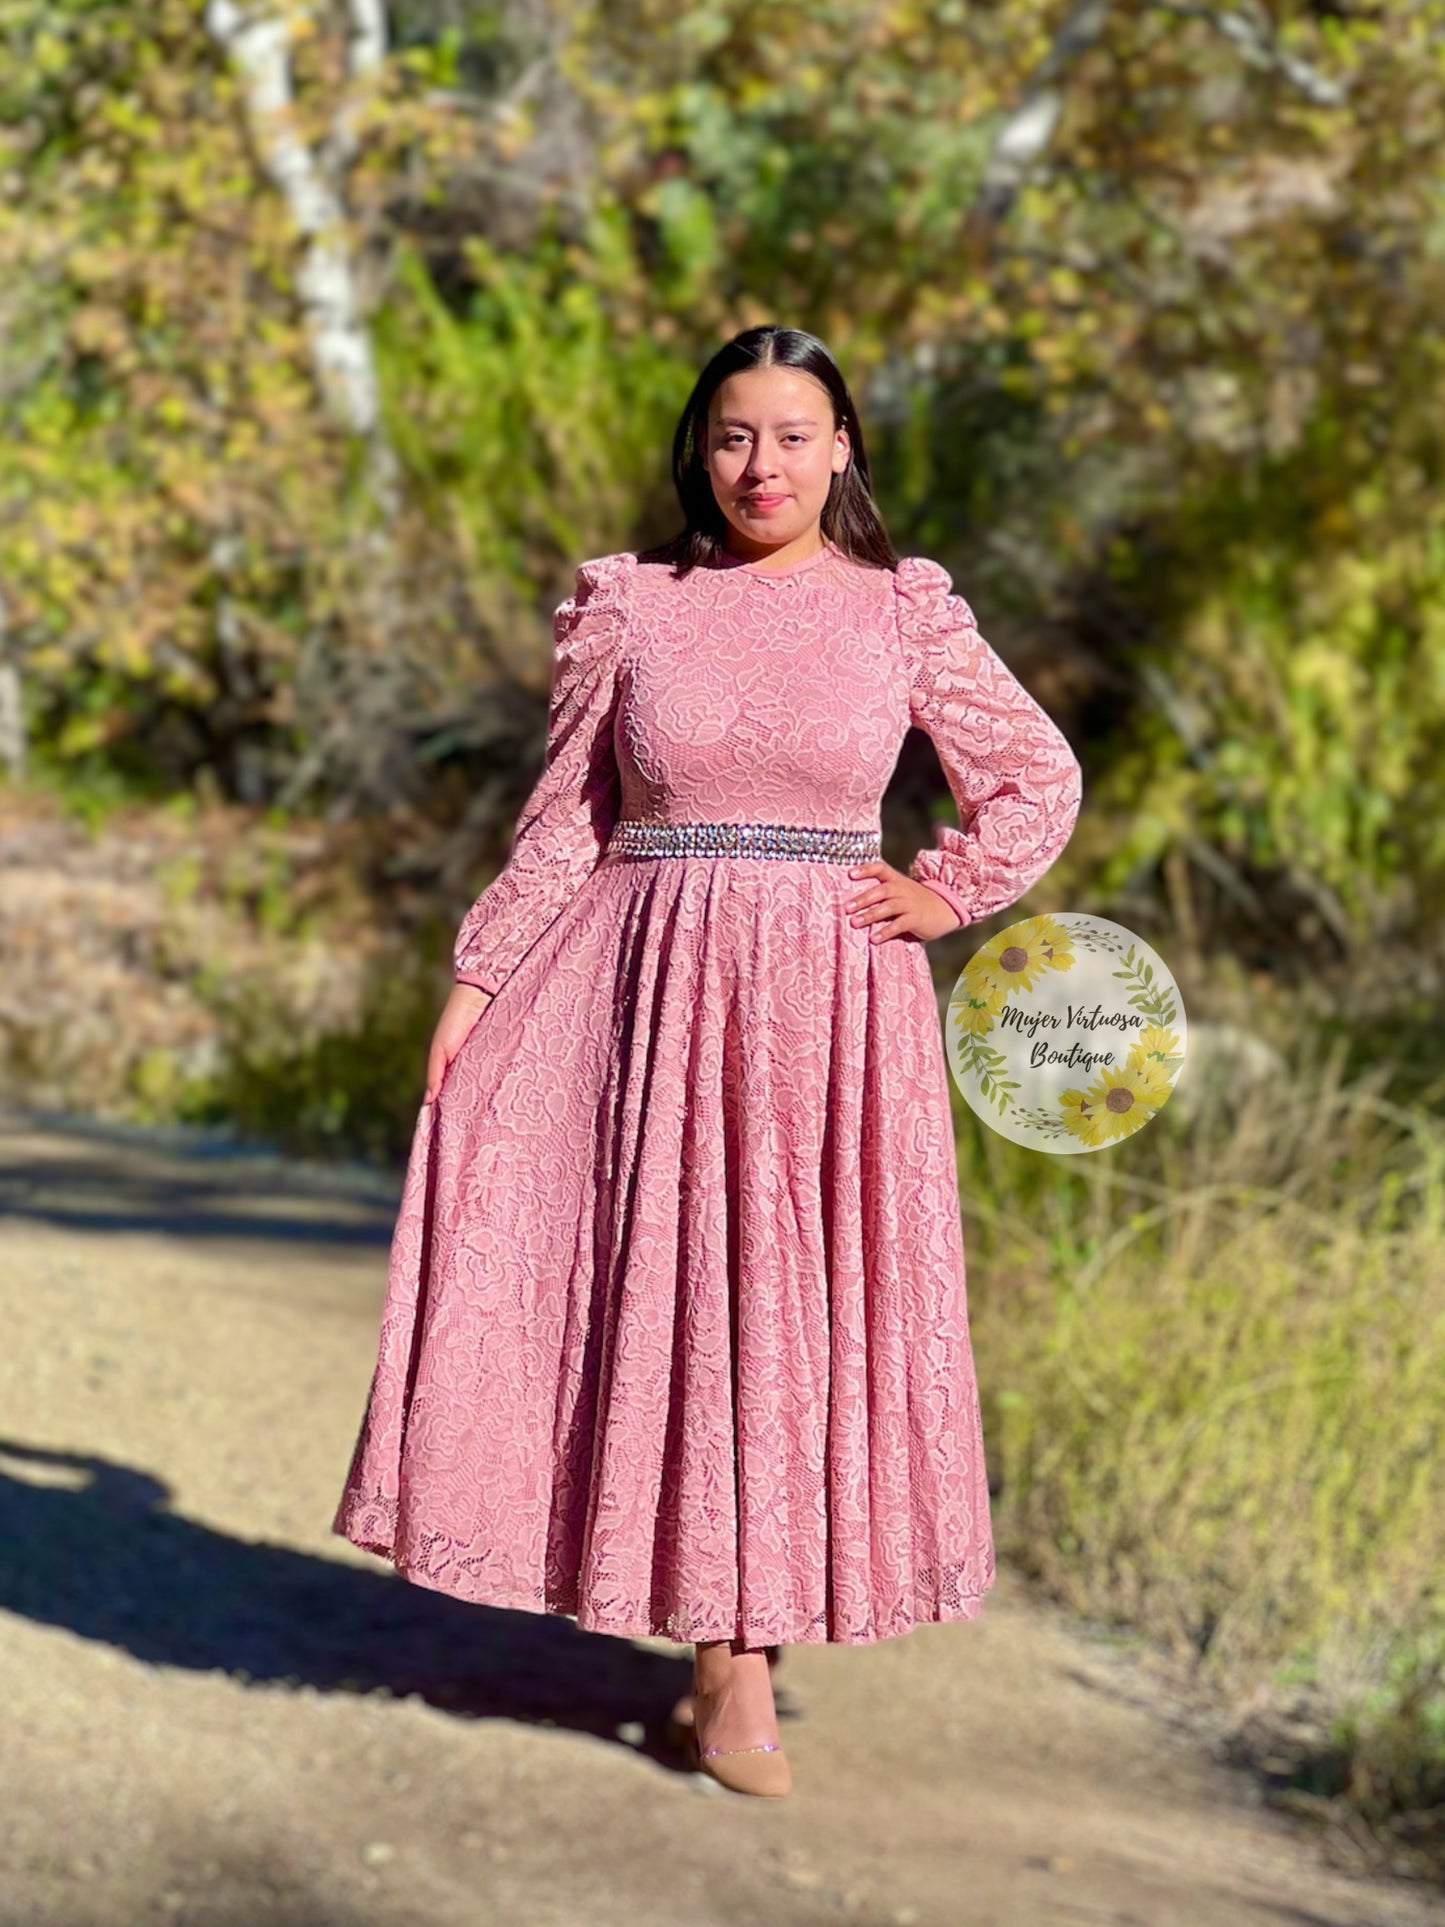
[333,856,994,1646]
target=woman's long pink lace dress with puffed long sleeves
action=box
[333,545,1081,1644]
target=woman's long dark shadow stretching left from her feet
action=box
[0,1438,692,1765]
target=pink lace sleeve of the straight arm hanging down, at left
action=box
[453,551,636,992]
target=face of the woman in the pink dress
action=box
[707,368,850,549]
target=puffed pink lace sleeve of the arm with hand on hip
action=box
[894,555,1083,925]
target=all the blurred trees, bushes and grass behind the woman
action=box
[0,0,1445,1871]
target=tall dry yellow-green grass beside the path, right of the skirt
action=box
[963,1050,1445,1842]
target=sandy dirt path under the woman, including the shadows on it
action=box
[0,1116,1437,1927]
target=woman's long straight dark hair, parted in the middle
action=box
[638,324,898,574]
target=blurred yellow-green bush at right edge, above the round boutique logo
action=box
[1092,435,1445,948]
